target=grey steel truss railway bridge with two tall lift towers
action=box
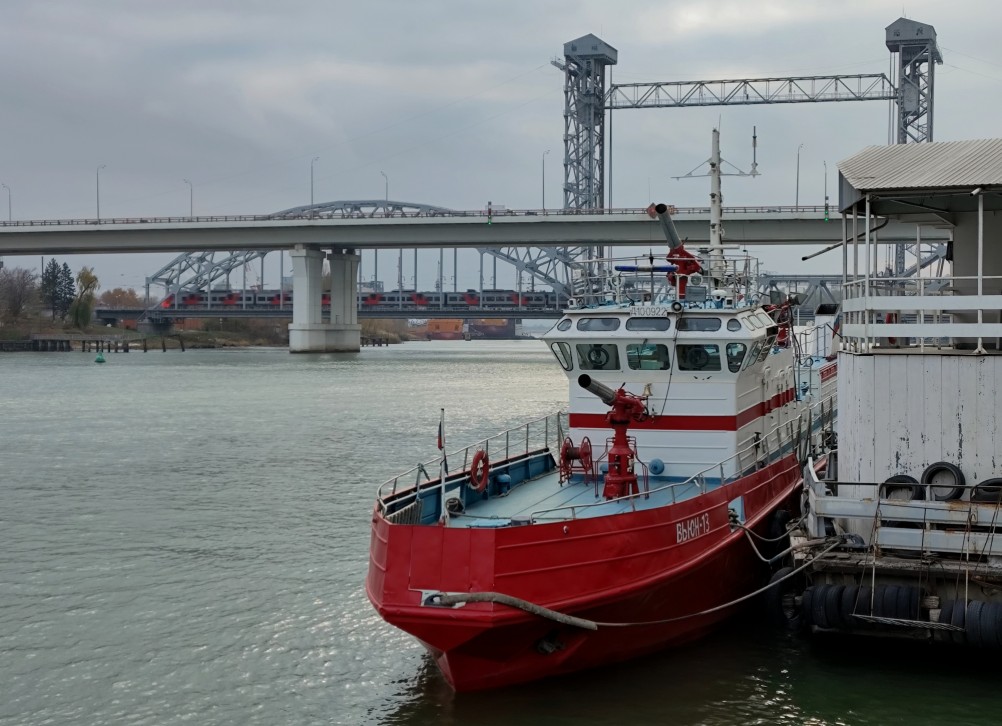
[131,18,943,322]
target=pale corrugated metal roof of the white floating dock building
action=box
[839,138,1002,191]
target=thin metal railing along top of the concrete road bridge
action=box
[0,204,825,228]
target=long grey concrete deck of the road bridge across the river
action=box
[0,206,948,255]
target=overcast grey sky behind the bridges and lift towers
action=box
[0,0,1002,288]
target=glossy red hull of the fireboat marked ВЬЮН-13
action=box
[366,456,802,691]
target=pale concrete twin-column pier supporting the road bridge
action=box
[289,245,362,352]
